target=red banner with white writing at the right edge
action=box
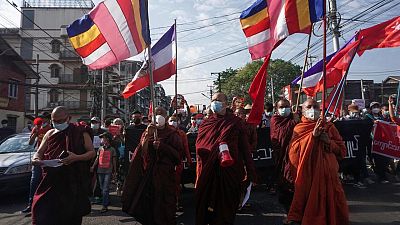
[372,121,400,159]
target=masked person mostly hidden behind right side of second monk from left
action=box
[168,116,193,212]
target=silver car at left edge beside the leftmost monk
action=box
[0,133,35,194]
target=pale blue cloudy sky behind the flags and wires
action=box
[0,0,400,104]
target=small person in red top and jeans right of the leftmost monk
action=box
[90,132,117,213]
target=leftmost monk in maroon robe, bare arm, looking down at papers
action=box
[32,107,95,225]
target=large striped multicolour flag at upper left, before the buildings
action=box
[67,0,151,70]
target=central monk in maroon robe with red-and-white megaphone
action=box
[195,93,256,225]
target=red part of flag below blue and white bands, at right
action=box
[307,40,360,96]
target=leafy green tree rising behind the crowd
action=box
[214,59,301,103]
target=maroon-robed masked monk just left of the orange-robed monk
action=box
[271,99,300,213]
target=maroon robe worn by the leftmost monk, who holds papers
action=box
[32,124,91,225]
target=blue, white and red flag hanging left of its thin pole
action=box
[122,25,176,98]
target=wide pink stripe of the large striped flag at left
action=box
[90,2,130,61]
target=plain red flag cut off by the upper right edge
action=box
[357,16,400,55]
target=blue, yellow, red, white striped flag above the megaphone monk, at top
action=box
[240,0,323,60]
